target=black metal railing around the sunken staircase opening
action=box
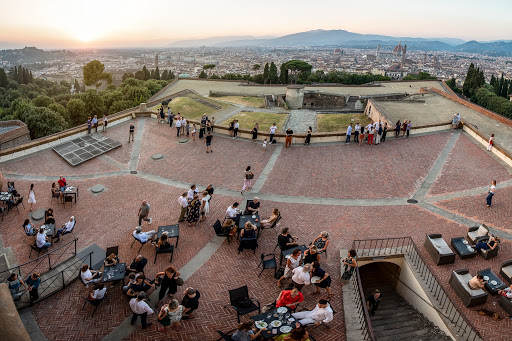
[352,237,482,341]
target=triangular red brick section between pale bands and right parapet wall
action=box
[429,134,512,196]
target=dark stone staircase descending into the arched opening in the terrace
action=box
[360,263,451,341]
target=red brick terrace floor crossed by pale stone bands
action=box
[0,119,512,341]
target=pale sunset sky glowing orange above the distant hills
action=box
[0,0,512,48]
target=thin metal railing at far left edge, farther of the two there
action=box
[0,238,78,282]
